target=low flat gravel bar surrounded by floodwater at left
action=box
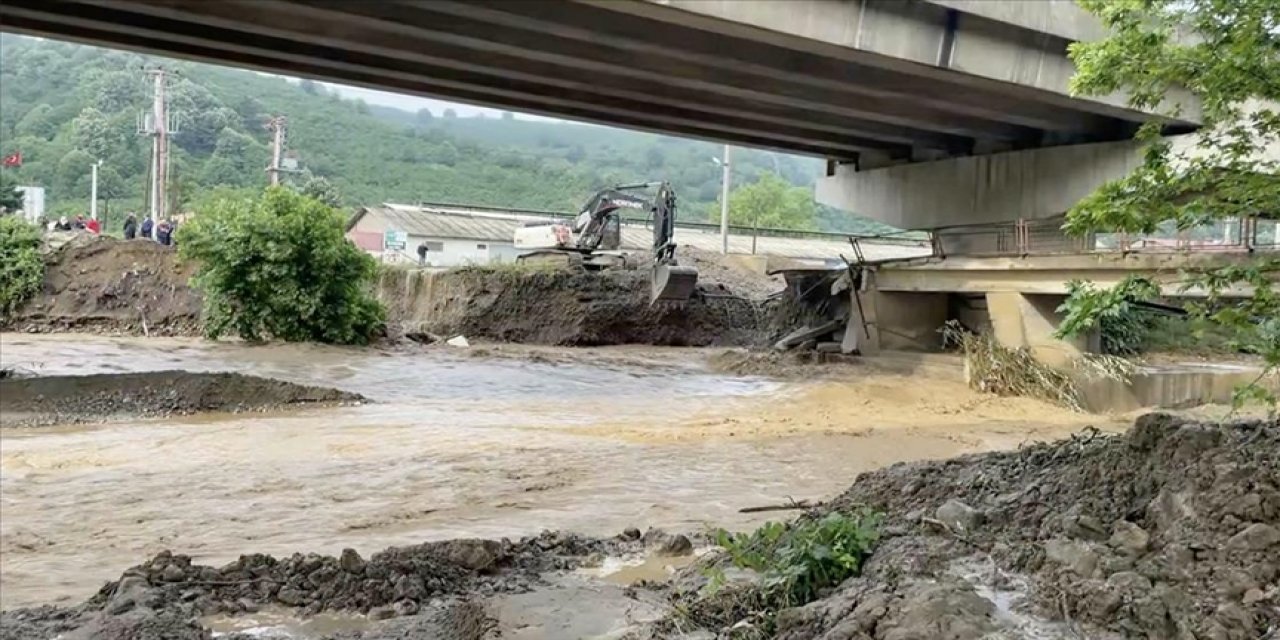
[0,371,365,426]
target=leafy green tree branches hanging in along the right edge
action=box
[1066,0,1280,407]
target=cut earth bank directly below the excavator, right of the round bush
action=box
[378,268,777,347]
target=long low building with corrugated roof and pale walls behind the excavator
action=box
[347,204,921,266]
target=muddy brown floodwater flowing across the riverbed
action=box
[0,334,1116,608]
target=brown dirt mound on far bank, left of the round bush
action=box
[4,234,201,335]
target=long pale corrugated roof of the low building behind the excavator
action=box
[347,204,928,260]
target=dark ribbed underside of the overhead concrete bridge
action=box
[0,0,1182,160]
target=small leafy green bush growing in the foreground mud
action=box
[712,511,882,611]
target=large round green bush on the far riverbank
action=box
[178,187,385,344]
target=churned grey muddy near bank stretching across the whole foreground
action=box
[0,415,1280,640]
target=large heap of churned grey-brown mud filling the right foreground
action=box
[660,415,1280,640]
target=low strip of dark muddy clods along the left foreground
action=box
[0,529,691,640]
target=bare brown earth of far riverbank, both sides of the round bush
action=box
[0,236,804,346]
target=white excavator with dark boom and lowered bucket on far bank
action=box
[515,182,698,303]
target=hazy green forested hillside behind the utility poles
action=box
[0,35,890,230]
